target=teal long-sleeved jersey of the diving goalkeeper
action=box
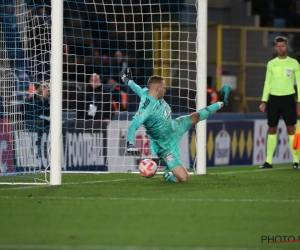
[127,80,175,155]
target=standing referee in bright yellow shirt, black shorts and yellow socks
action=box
[259,36,300,169]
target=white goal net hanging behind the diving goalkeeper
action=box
[0,0,206,182]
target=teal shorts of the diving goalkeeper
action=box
[157,116,192,171]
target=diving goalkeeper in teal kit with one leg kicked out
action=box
[121,69,230,182]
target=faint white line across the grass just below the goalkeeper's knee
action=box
[0,196,300,203]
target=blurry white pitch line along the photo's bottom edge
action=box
[0,244,275,250]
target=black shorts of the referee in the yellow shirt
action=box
[267,95,297,127]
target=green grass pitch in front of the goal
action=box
[0,164,300,250]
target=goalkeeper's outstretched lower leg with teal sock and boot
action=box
[190,84,231,125]
